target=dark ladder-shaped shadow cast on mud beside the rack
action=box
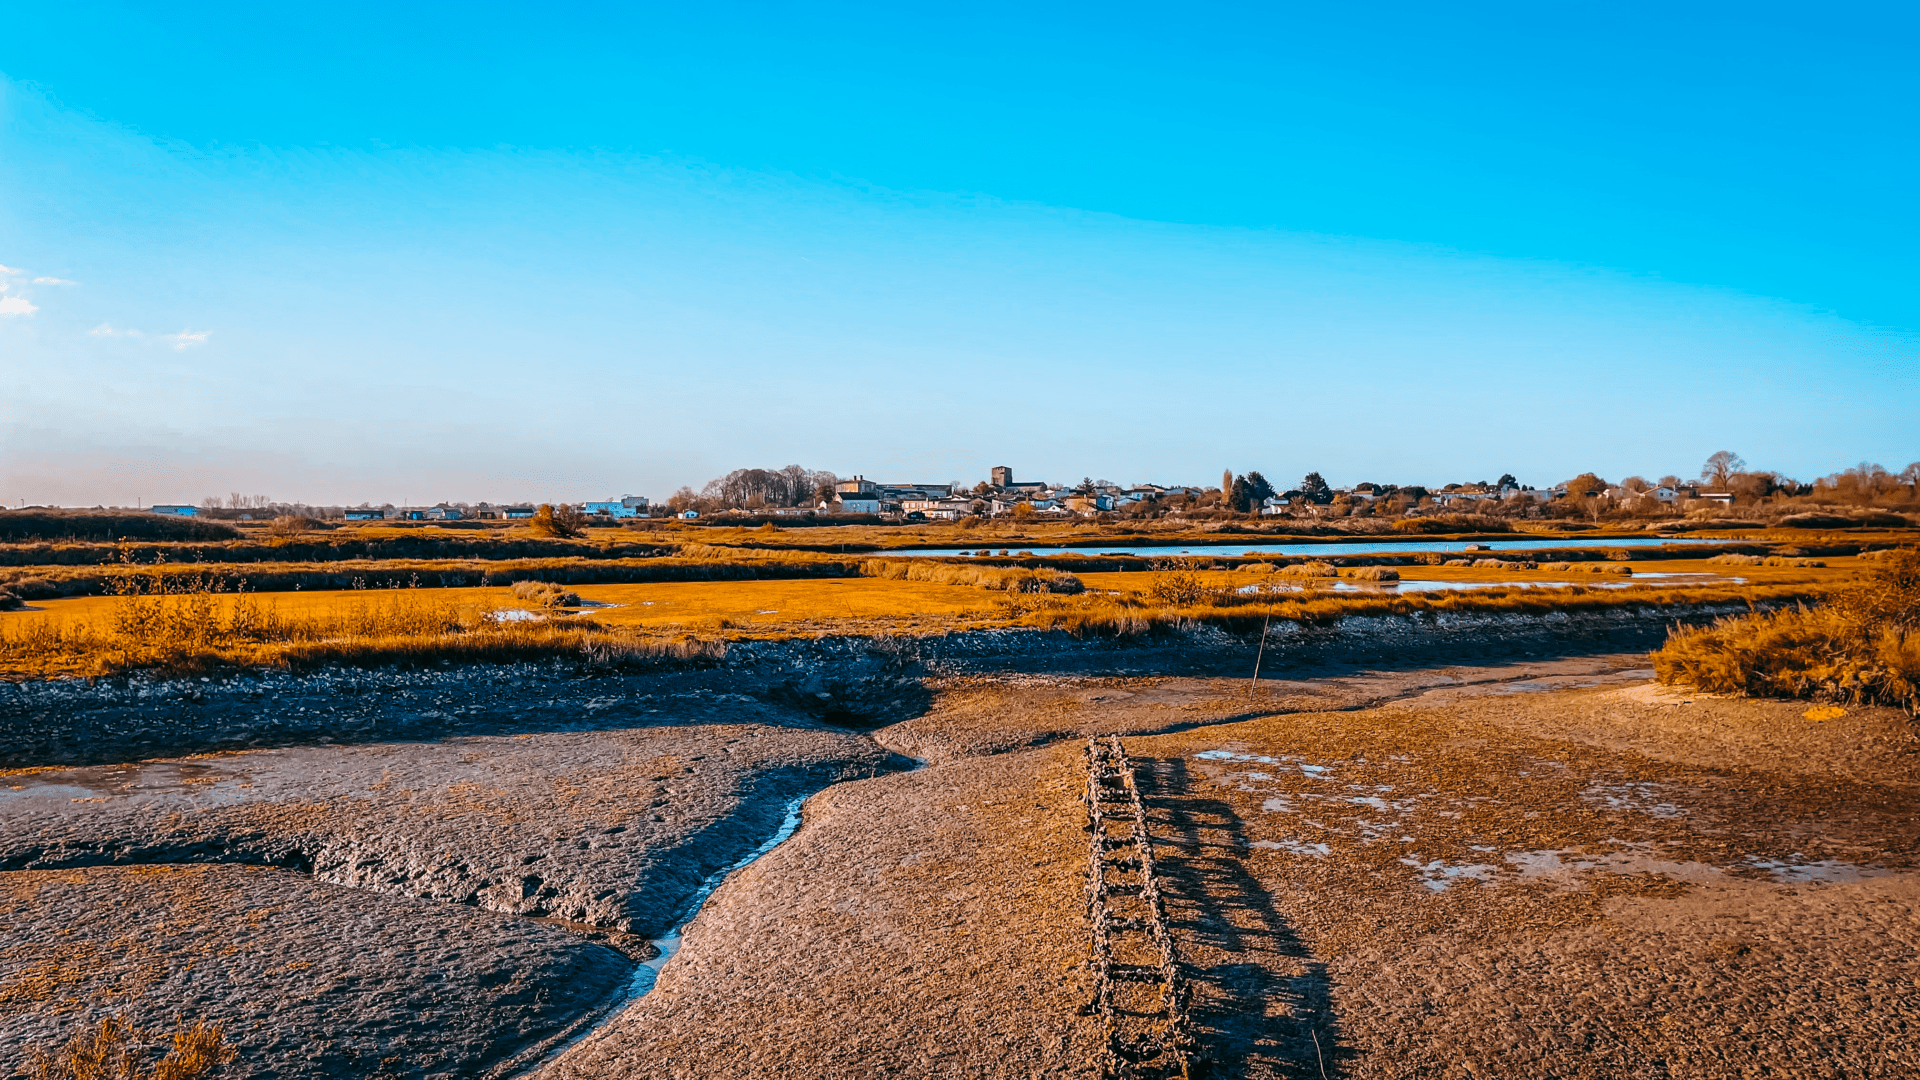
[1139,759,1344,1078]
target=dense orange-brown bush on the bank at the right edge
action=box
[1653,548,1920,713]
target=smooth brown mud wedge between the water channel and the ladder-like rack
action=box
[541,753,1098,1080]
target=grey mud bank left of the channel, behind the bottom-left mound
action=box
[0,724,897,944]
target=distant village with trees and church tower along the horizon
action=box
[105,452,1889,523]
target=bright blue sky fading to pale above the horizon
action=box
[0,4,1920,505]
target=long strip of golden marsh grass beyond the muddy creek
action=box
[0,552,1878,678]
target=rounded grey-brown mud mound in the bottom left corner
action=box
[0,867,632,1078]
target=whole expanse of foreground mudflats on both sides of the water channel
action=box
[0,655,1920,1080]
